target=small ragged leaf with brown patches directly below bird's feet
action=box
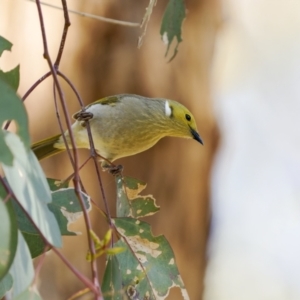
[116,176,159,218]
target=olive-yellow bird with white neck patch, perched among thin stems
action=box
[31,94,203,170]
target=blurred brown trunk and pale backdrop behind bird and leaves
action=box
[0,0,300,300]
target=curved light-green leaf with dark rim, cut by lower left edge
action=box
[0,195,18,280]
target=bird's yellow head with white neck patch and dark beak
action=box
[164,100,203,145]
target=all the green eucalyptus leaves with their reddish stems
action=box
[0,0,188,300]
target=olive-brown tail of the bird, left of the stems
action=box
[31,134,64,160]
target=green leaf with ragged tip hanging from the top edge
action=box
[160,0,185,62]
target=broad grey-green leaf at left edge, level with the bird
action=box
[0,83,30,166]
